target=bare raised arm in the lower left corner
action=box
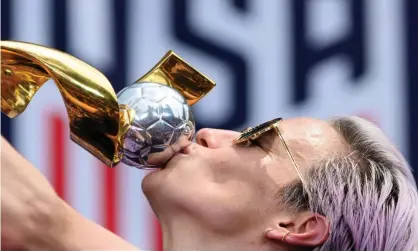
[0,137,140,251]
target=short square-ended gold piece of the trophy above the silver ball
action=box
[136,51,215,105]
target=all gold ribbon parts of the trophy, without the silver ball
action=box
[1,41,215,167]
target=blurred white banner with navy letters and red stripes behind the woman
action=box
[1,0,418,250]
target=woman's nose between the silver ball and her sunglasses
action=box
[196,128,239,148]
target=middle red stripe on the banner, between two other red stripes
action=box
[102,164,118,233]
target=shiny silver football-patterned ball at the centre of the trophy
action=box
[118,83,195,168]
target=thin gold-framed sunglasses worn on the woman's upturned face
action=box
[233,118,305,184]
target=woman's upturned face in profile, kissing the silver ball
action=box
[142,118,342,233]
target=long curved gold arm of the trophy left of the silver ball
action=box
[1,41,124,166]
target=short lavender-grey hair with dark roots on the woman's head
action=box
[280,117,418,251]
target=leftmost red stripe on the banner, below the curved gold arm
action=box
[47,114,67,200]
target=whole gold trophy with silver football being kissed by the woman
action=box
[1,41,215,169]
